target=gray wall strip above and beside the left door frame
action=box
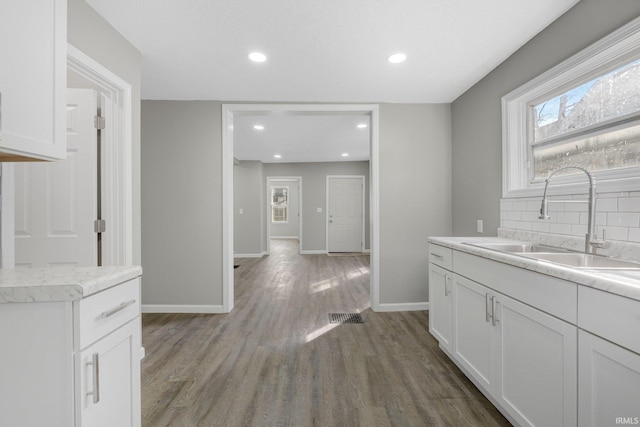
[67,0,145,266]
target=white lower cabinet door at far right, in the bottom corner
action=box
[578,330,640,427]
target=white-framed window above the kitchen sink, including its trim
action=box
[502,18,640,197]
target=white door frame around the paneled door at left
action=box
[0,44,133,268]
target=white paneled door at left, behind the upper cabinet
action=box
[15,89,98,267]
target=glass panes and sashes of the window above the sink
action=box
[531,60,640,181]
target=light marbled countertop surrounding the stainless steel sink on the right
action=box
[429,237,640,301]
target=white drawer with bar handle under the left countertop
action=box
[74,278,140,350]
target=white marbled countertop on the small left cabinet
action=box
[0,266,142,303]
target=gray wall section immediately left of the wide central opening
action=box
[142,101,222,305]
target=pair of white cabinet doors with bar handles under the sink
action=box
[453,275,577,426]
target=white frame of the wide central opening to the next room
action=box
[222,104,380,313]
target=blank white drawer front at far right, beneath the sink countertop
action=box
[578,286,640,353]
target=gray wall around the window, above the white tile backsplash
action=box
[452,0,640,236]
